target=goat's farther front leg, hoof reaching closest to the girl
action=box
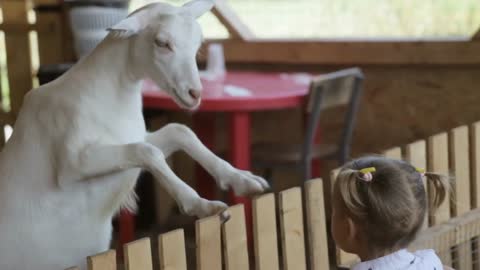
[146,124,269,195]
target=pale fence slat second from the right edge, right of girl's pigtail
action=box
[449,126,472,270]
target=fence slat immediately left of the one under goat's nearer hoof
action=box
[158,229,187,270]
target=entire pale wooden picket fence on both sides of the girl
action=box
[65,122,480,270]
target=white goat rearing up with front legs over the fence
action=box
[0,0,268,270]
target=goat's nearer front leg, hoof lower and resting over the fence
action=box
[59,142,227,218]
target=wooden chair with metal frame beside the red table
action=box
[252,68,364,180]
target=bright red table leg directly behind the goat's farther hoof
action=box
[229,112,252,243]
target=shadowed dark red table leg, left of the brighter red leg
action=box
[193,113,216,200]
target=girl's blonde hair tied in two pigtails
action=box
[335,156,449,249]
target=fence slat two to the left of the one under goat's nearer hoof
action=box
[123,238,153,270]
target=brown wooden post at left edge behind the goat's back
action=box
[2,0,32,116]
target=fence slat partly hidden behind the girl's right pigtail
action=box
[427,133,450,225]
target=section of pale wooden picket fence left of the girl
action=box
[66,179,330,270]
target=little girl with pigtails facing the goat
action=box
[332,156,449,270]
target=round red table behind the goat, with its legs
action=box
[121,72,310,247]
